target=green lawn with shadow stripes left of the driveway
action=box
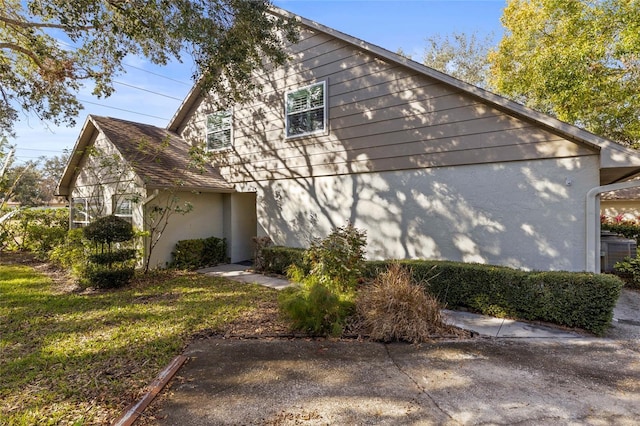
[0,265,277,425]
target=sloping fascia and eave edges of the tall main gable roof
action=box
[167,7,640,184]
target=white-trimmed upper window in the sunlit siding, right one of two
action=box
[285,81,327,137]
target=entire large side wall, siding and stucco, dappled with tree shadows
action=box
[184,28,599,270]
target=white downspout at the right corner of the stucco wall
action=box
[585,180,640,273]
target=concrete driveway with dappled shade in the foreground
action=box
[140,291,640,425]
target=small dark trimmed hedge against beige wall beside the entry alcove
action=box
[169,237,227,269]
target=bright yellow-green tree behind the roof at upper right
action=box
[490,0,640,146]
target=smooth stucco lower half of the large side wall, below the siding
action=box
[238,156,598,270]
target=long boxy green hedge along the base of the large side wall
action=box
[366,260,623,335]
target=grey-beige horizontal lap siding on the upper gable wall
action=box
[179,27,593,183]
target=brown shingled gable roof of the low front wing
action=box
[58,115,233,195]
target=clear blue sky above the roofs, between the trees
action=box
[9,0,506,162]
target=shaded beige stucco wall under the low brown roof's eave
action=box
[147,191,224,268]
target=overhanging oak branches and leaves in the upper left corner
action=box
[0,0,296,135]
